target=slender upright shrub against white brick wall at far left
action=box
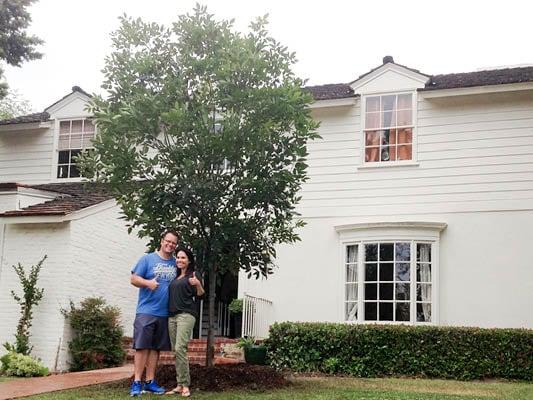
[4,255,47,355]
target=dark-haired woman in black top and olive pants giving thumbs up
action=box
[166,247,204,397]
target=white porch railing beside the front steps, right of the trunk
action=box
[242,293,273,339]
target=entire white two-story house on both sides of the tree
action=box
[0,57,533,370]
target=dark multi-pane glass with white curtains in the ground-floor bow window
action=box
[345,241,432,323]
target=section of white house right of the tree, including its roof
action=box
[239,57,533,336]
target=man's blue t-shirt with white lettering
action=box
[131,252,177,317]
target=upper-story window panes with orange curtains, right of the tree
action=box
[364,93,413,163]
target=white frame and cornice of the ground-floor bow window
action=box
[335,222,446,325]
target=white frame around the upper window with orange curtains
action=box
[358,90,418,169]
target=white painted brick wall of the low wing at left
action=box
[0,206,146,370]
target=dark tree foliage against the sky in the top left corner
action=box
[0,0,43,98]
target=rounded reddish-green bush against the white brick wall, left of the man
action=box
[62,297,125,371]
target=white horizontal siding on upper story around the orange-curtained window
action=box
[299,92,533,217]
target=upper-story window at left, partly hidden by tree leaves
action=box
[57,119,95,179]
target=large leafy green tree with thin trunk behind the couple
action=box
[83,6,318,365]
